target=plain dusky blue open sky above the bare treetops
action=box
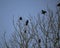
[0,0,57,36]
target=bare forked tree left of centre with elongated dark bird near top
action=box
[10,15,41,48]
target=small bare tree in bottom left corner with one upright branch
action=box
[0,32,10,48]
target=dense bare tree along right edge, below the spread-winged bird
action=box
[37,3,60,48]
